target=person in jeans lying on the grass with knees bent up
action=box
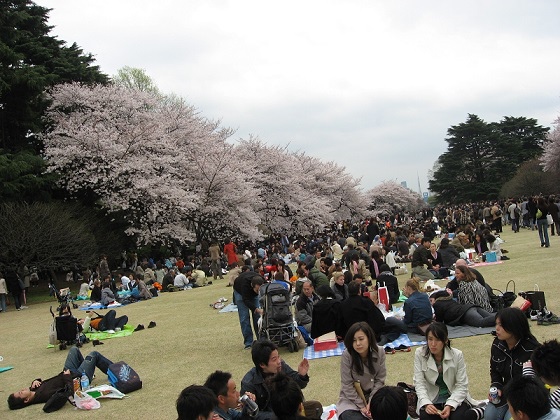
[8,347,113,410]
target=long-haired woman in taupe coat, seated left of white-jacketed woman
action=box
[336,322,387,420]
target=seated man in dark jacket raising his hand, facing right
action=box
[241,338,310,412]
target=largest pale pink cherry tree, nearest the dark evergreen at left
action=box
[44,83,255,243]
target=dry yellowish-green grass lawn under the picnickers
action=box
[0,226,560,419]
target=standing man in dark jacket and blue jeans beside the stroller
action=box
[233,271,264,350]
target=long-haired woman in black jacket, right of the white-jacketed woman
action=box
[484,307,539,420]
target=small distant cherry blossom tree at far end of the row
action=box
[366,181,424,216]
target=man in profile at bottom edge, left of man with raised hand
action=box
[204,370,255,420]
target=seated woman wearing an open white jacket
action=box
[414,322,471,420]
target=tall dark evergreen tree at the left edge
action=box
[0,0,109,200]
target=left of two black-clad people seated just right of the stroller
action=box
[311,284,343,338]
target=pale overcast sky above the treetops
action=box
[36,0,560,191]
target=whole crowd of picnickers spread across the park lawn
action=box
[4,197,560,420]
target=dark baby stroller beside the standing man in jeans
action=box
[259,283,299,353]
